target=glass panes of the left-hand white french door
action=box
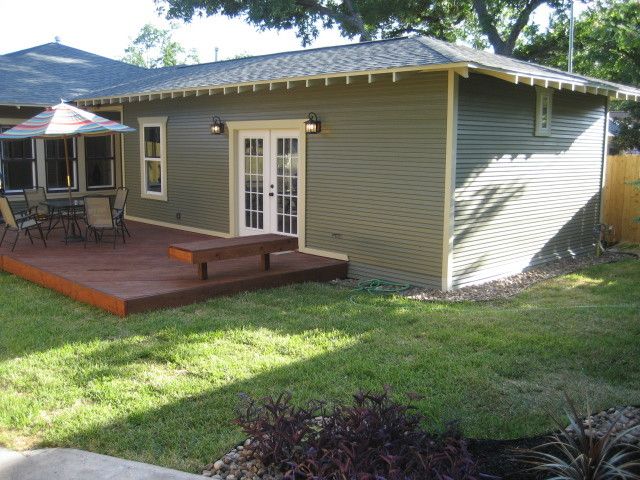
[244,138,264,230]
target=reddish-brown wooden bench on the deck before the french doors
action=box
[169,234,298,280]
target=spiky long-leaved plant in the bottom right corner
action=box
[525,395,640,480]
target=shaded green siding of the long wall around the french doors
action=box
[124,73,447,286]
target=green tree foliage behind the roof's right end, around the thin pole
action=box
[515,0,640,151]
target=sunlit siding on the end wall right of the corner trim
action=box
[453,75,605,287]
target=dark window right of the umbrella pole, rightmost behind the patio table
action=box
[84,135,116,190]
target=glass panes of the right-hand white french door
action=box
[275,138,299,235]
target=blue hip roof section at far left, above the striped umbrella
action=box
[0,43,146,106]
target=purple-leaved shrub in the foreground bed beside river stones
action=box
[236,389,477,480]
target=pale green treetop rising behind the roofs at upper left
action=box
[122,24,198,68]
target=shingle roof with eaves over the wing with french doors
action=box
[78,37,640,103]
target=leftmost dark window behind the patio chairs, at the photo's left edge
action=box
[0,126,37,197]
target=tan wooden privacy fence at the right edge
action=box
[603,155,640,243]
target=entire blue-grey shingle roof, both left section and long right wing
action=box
[0,37,640,105]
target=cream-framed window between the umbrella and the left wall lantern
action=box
[138,117,167,200]
